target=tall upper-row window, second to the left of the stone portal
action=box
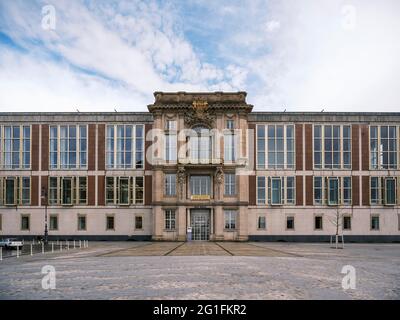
[49,125,87,169]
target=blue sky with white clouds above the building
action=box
[0,0,400,112]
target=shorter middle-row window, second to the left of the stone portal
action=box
[48,177,87,205]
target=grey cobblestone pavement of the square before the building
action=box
[0,242,400,299]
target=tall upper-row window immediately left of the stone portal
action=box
[106,124,144,169]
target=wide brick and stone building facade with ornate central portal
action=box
[0,92,400,242]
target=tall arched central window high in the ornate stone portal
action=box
[189,127,212,163]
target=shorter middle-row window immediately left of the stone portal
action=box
[106,177,144,205]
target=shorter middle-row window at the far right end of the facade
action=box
[370,177,397,205]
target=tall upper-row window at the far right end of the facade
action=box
[369,126,398,169]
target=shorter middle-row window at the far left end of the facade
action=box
[0,177,31,206]
